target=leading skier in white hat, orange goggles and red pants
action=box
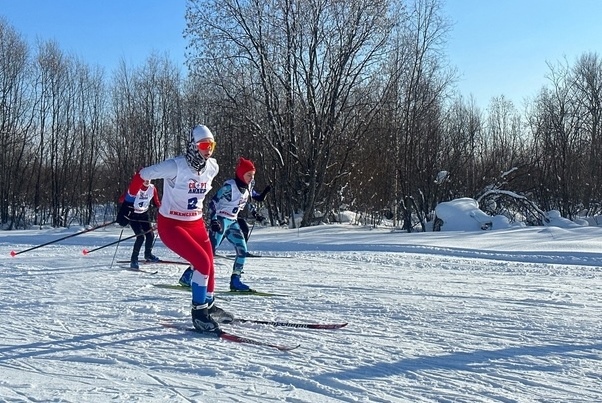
[125,125,232,335]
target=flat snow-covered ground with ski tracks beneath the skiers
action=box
[0,201,602,403]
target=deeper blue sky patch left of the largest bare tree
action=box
[0,0,186,73]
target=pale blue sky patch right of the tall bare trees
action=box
[443,0,602,108]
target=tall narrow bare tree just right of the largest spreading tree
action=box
[378,0,454,231]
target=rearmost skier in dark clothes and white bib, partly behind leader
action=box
[117,181,161,270]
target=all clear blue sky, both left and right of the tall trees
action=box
[0,0,602,108]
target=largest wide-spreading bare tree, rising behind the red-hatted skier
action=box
[187,0,393,225]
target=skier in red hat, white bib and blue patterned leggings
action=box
[180,157,271,291]
